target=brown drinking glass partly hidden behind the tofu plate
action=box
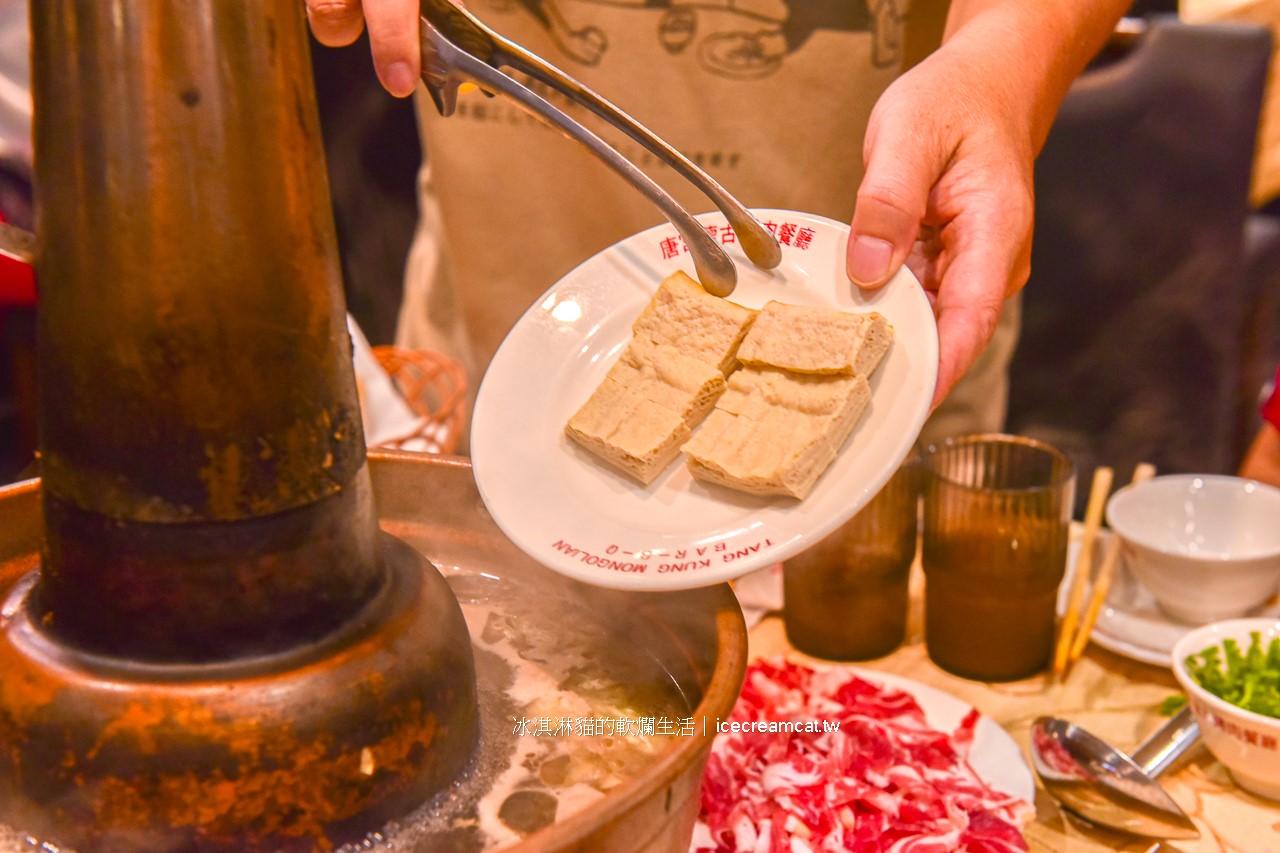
[782,455,919,661]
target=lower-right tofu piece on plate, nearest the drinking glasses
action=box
[681,366,870,498]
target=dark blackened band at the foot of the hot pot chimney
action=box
[37,469,385,662]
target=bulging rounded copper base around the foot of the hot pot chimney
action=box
[0,484,477,853]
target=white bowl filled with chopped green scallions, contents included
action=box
[1172,619,1280,799]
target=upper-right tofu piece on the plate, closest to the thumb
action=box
[737,301,893,377]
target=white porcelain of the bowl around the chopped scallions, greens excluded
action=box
[1172,619,1280,799]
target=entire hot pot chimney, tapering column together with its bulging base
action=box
[0,0,477,853]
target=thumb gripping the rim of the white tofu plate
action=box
[845,117,941,287]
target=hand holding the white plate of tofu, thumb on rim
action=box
[847,47,1037,406]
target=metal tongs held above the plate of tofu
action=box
[419,0,782,296]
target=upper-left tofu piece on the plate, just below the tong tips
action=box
[631,272,755,374]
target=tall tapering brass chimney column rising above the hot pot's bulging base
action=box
[31,0,385,662]
